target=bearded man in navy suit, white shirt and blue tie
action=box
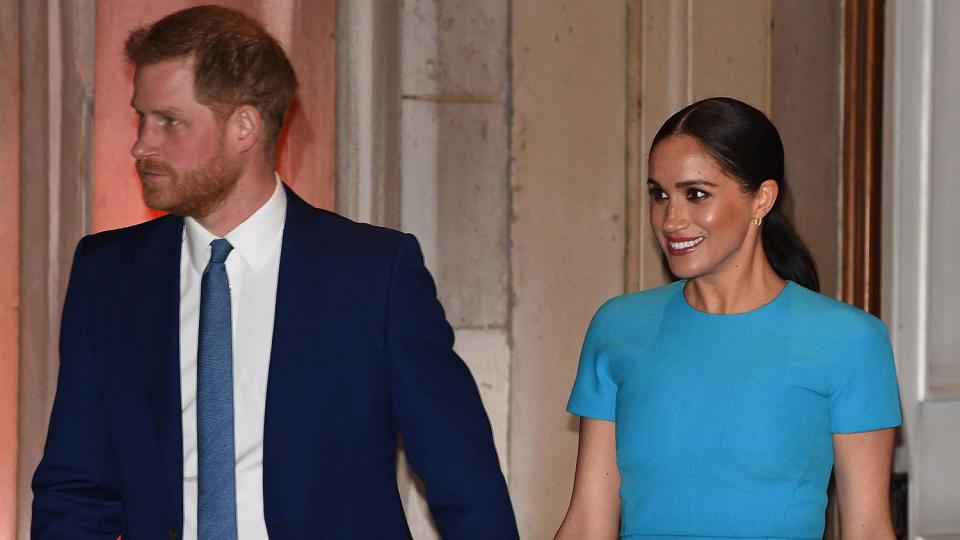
[33,6,517,540]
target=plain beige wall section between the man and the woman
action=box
[509,1,627,538]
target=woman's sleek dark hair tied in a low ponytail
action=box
[650,97,820,291]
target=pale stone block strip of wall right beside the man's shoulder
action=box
[399,0,510,538]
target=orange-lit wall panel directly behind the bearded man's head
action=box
[91,0,336,232]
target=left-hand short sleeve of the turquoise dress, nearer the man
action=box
[567,308,617,421]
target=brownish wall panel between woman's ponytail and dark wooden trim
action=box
[769,0,843,296]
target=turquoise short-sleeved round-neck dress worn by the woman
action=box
[567,281,900,540]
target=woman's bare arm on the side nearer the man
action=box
[554,418,620,540]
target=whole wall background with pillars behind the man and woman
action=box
[0,0,960,540]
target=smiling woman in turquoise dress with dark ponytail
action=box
[557,98,900,539]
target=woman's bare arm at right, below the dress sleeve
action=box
[832,428,895,540]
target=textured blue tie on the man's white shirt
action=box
[197,238,237,540]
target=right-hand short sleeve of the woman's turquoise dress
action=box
[830,317,901,433]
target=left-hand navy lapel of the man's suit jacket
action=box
[129,216,183,523]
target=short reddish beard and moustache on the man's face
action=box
[137,141,240,218]
